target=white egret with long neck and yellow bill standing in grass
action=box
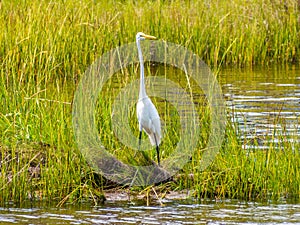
[136,32,161,165]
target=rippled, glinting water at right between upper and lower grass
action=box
[219,67,300,148]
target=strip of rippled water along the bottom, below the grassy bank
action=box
[0,200,300,225]
